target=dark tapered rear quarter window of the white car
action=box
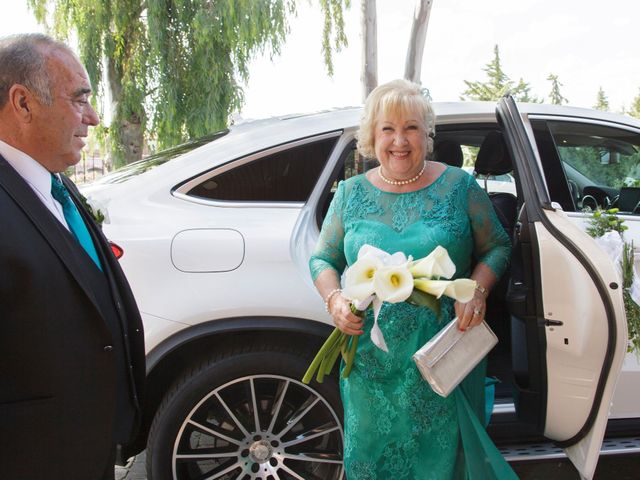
[187,137,337,202]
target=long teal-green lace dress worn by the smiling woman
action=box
[309,167,517,480]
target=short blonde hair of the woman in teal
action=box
[356,79,436,158]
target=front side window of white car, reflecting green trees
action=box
[547,121,640,213]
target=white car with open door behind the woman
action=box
[84,98,640,480]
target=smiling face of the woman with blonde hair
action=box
[374,110,427,180]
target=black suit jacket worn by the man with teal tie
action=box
[0,156,145,480]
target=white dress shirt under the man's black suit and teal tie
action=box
[0,140,69,230]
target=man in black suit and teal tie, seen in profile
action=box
[0,34,145,480]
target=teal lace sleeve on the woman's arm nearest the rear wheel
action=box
[309,182,347,281]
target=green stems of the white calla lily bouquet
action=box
[302,305,364,385]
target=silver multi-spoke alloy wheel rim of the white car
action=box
[172,375,343,480]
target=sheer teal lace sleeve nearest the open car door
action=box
[467,176,511,278]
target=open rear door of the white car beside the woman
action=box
[496,96,627,479]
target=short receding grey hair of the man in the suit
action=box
[0,33,75,109]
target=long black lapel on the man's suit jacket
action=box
[0,155,100,311]
